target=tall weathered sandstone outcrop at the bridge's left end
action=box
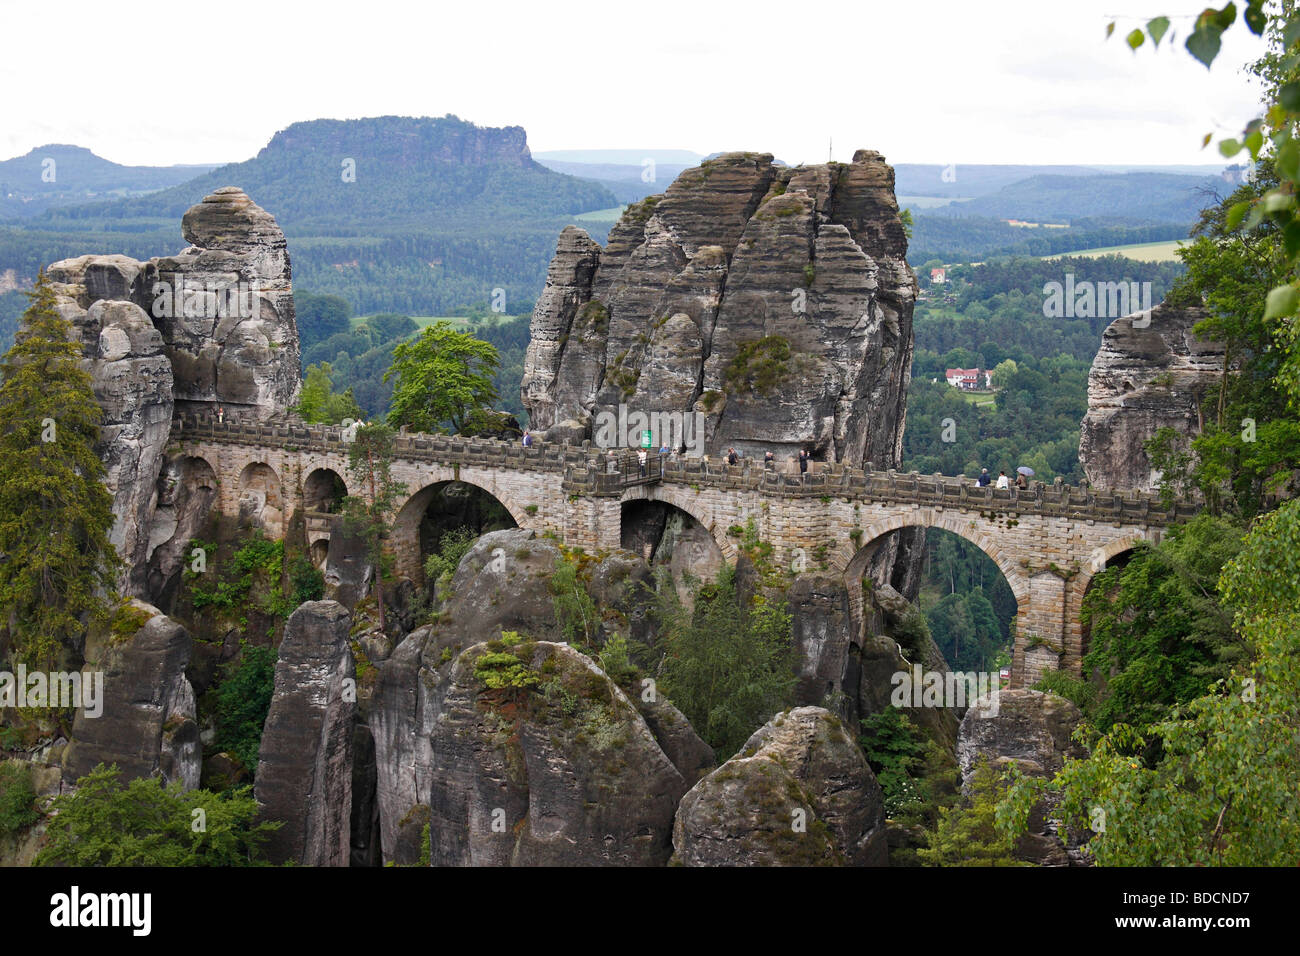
[48,186,299,601]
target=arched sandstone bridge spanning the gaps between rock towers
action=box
[172,418,1197,687]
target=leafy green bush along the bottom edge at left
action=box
[35,763,281,866]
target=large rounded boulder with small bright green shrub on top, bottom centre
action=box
[428,641,686,866]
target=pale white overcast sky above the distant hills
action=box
[0,0,1261,165]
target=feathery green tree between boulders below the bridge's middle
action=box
[659,567,796,760]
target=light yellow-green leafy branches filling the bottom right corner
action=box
[1004,501,1300,866]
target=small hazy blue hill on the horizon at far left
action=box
[0,143,216,220]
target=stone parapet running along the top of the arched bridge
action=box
[173,415,1201,524]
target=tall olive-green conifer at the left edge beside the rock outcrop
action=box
[0,272,121,669]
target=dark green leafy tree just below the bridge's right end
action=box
[1066,514,1247,731]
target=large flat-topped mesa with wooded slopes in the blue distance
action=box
[0,116,618,315]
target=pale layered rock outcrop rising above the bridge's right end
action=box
[1079,304,1223,490]
